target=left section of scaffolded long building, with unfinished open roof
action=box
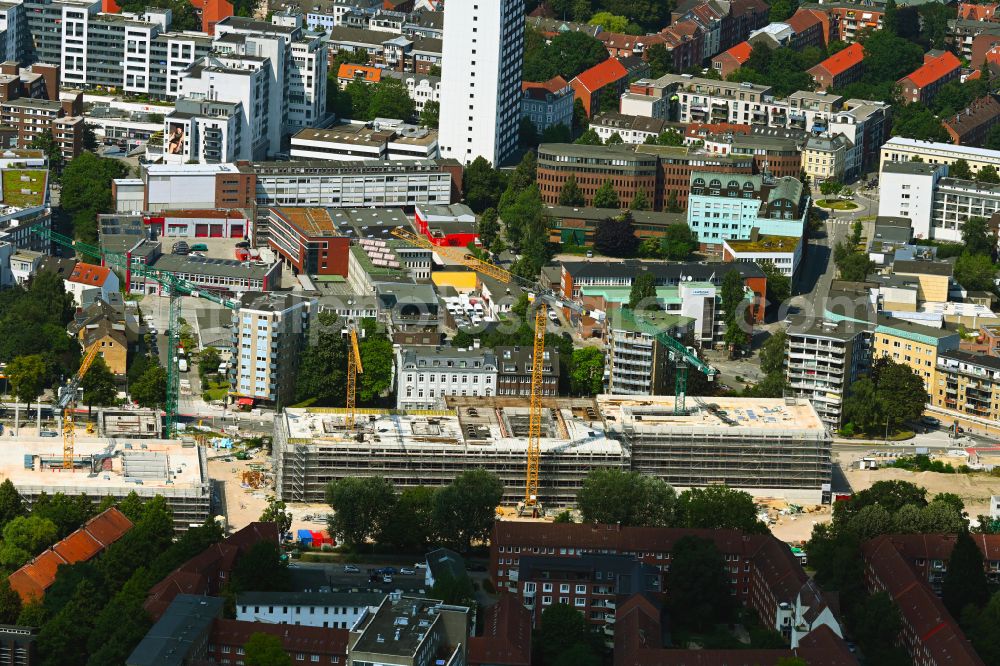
[273,397,628,506]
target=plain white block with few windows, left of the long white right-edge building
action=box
[878,161,948,238]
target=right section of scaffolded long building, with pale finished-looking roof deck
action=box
[597,395,832,504]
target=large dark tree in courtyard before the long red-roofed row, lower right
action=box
[667,536,733,631]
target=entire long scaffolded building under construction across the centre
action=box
[274,396,832,507]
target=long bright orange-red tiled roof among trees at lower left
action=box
[7,507,132,603]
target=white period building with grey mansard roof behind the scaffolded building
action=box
[396,347,497,409]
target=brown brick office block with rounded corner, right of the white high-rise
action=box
[536,143,754,211]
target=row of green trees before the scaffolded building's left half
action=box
[326,469,503,553]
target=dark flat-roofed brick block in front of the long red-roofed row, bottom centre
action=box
[516,553,664,636]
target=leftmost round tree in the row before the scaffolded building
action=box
[326,476,396,548]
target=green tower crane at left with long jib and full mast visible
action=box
[32,228,240,438]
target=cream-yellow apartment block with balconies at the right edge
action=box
[931,351,1000,435]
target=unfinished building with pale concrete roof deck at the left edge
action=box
[0,435,211,530]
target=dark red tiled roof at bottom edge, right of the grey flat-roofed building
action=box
[468,594,531,666]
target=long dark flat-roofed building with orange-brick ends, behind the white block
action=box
[560,259,767,323]
